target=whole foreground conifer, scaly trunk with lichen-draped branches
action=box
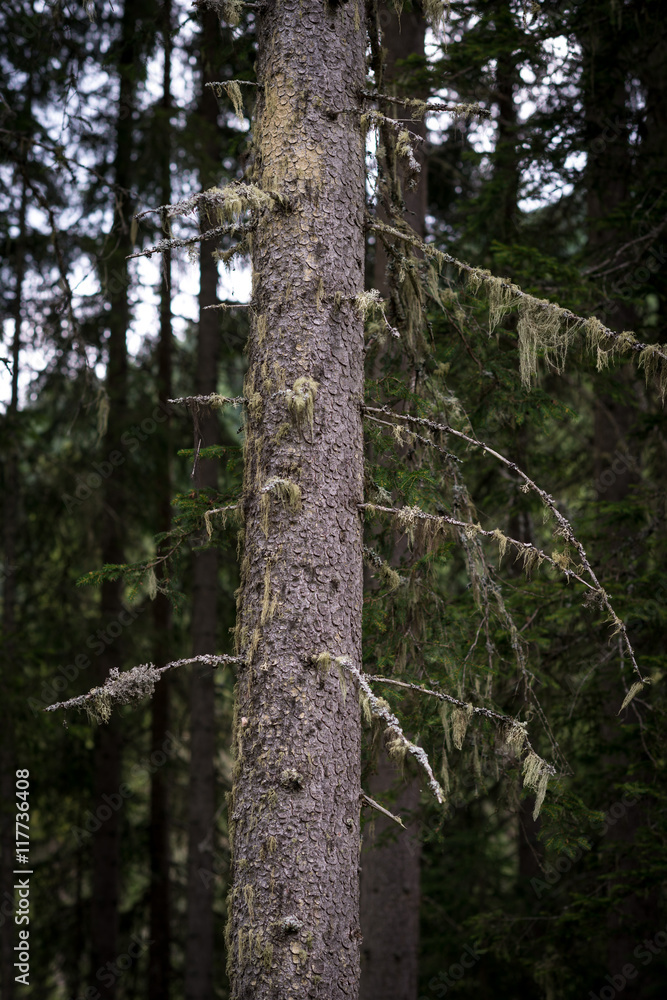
[41,0,665,998]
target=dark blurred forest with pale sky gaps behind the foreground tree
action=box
[0,0,667,1000]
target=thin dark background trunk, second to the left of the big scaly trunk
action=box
[148,0,172,1000]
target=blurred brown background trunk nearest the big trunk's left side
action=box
[185,11,220,1000]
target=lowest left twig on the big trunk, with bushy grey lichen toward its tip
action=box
[44,653,244,722]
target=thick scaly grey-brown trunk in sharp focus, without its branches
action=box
[228,0,366,1000]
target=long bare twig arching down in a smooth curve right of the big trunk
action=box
[362,405,650,685]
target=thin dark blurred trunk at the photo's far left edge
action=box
[0,168,29,1000]
